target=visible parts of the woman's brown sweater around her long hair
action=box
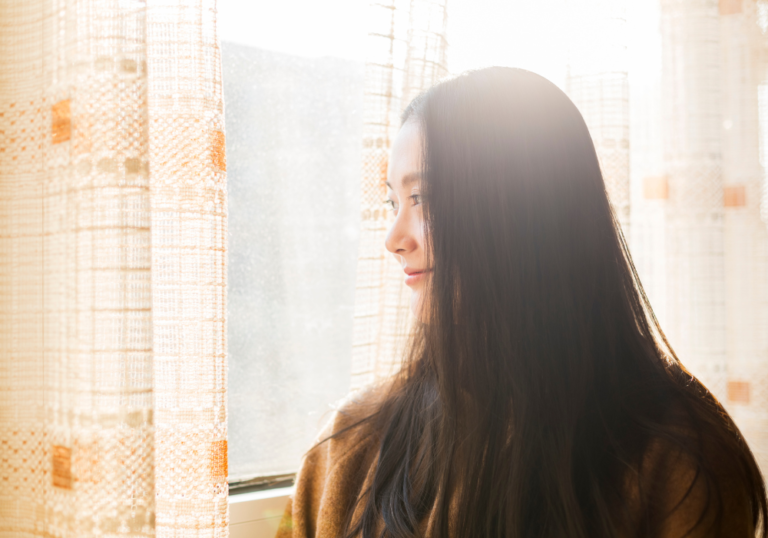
[277,385,755,538]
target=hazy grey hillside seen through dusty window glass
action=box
[222,42,363,480]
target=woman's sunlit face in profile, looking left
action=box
[385,121,432,319]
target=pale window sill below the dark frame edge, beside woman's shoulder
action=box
[229,486,293,538]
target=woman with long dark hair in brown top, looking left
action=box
[279,67,768,538]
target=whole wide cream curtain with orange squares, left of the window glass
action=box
[0,0,227,538]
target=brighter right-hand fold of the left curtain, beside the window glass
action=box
[147,0,228,538]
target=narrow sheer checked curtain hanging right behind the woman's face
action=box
[351,0,447,389]
